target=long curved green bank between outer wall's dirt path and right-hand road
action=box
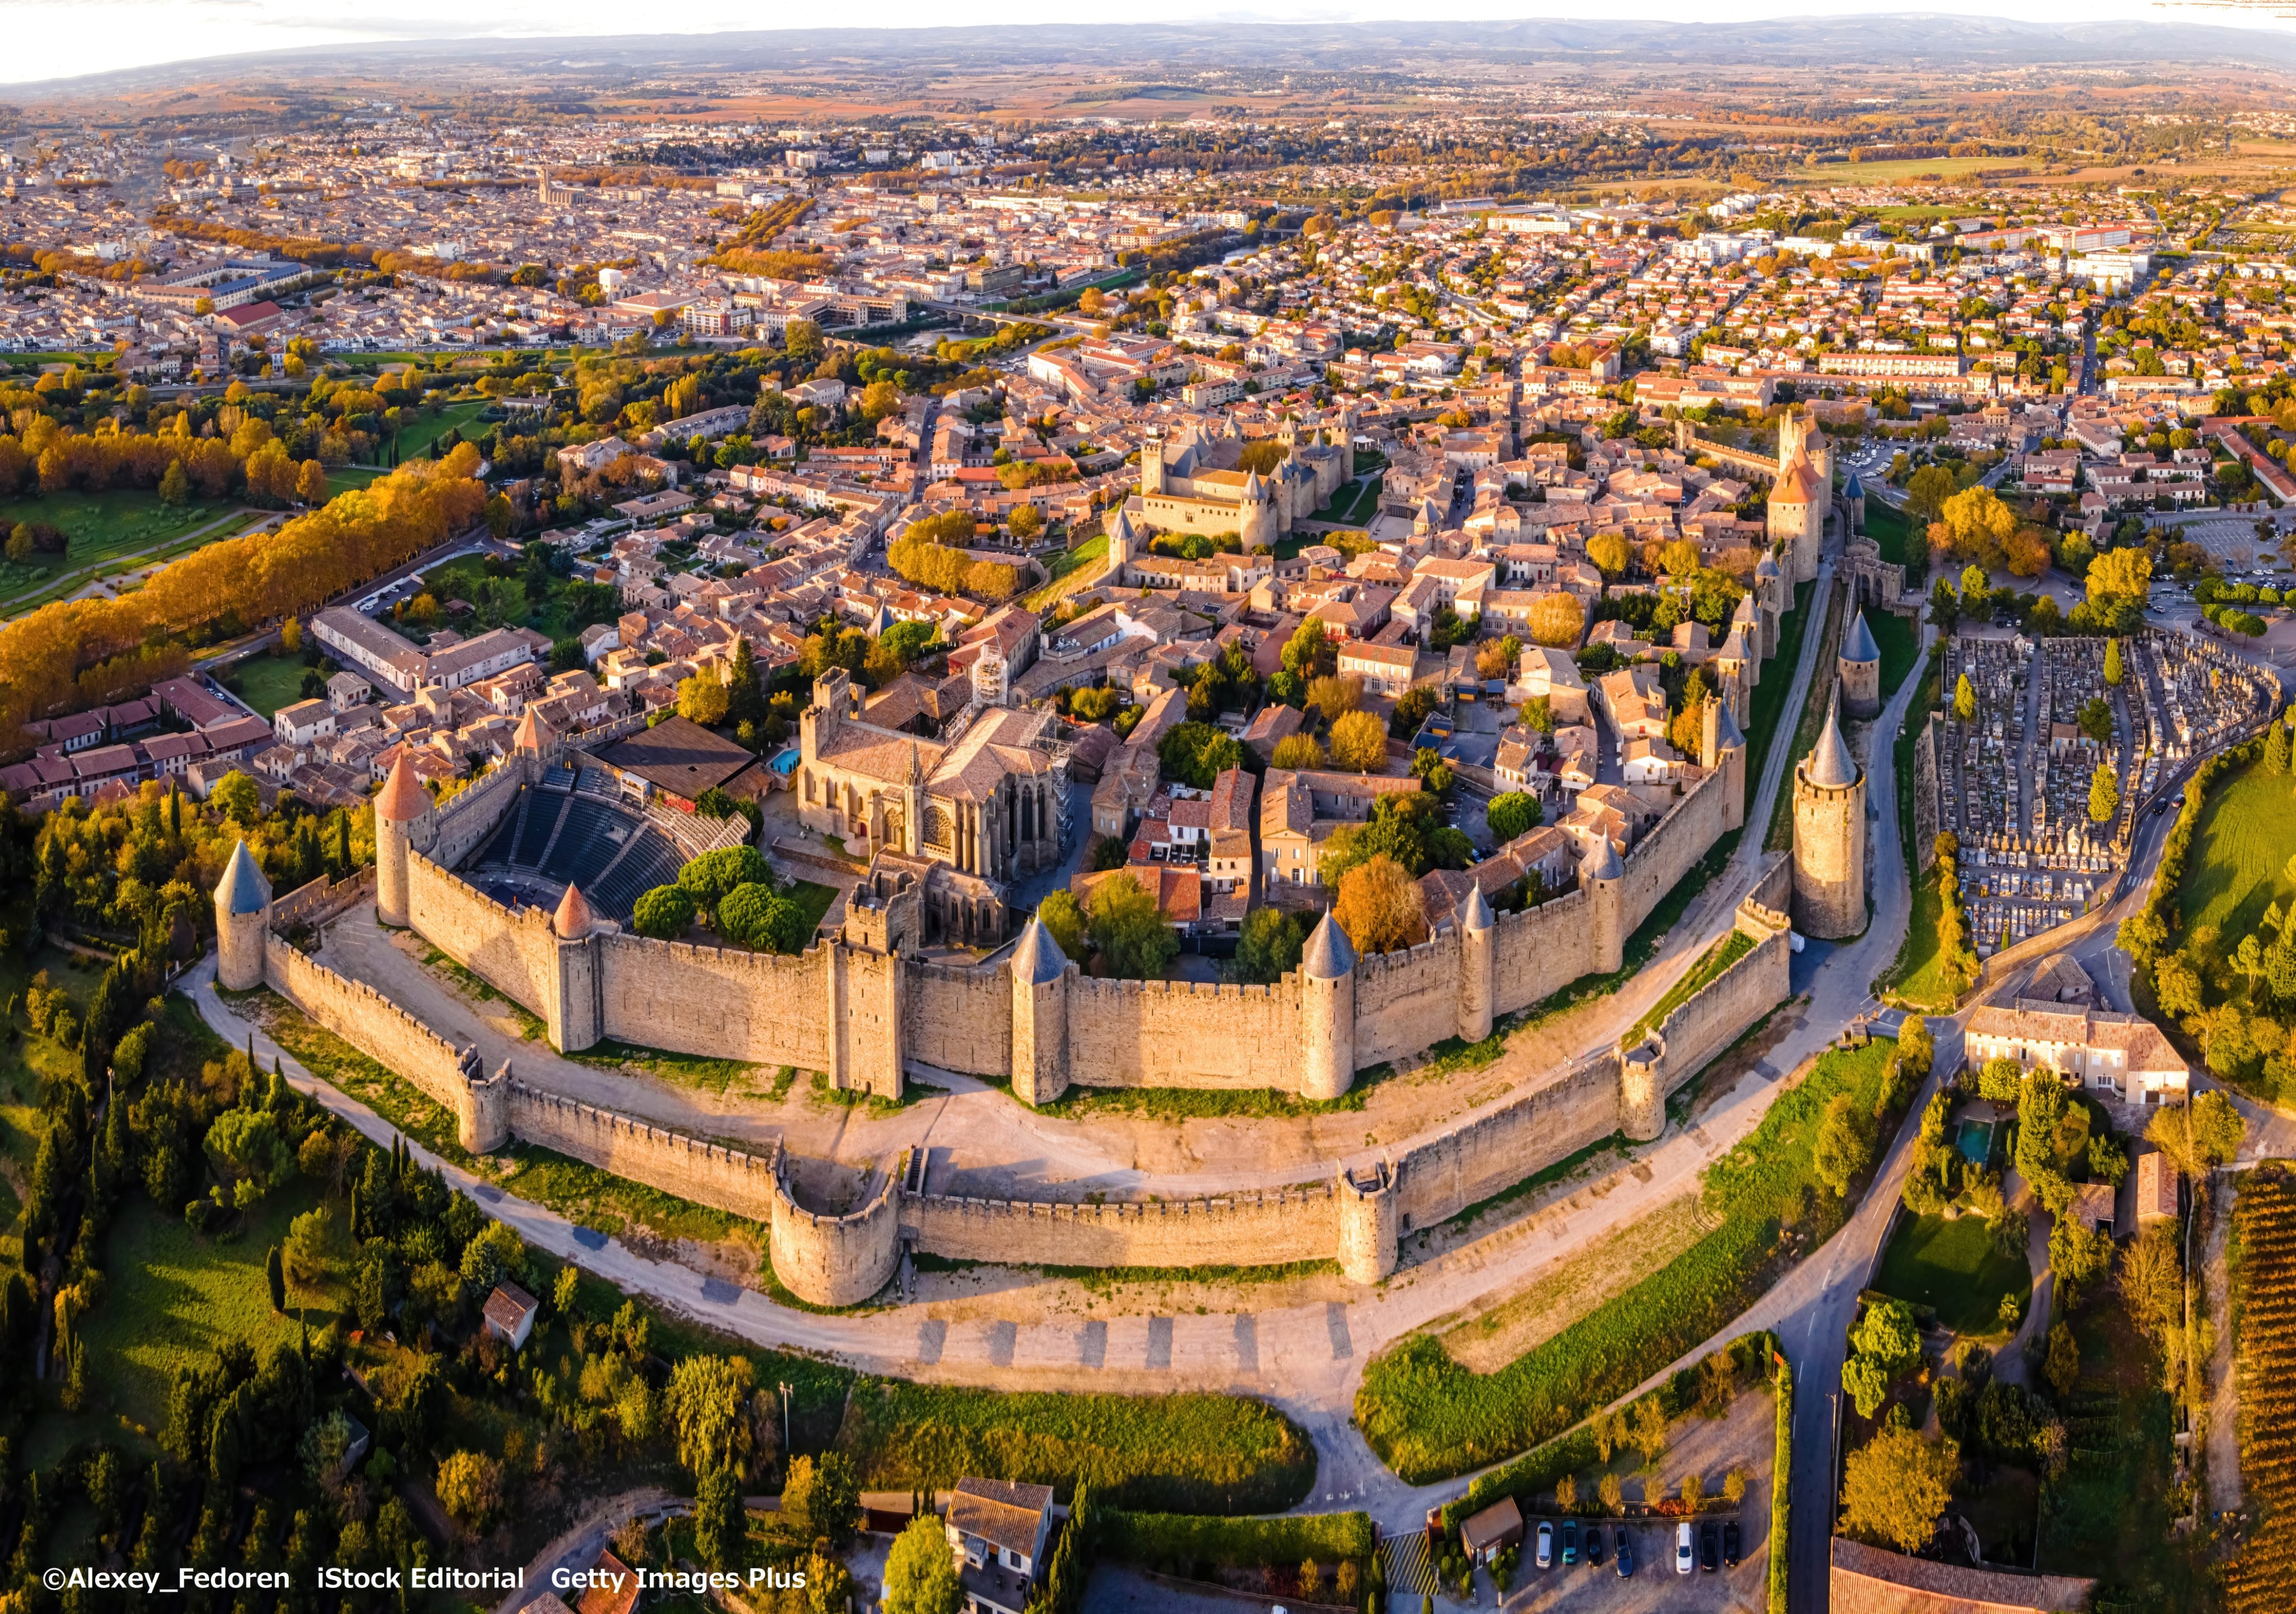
[1355,1040,1896,1486]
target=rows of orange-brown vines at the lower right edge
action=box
[2225,1162,2296,1614]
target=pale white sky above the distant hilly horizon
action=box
[13,0,2296,82]
